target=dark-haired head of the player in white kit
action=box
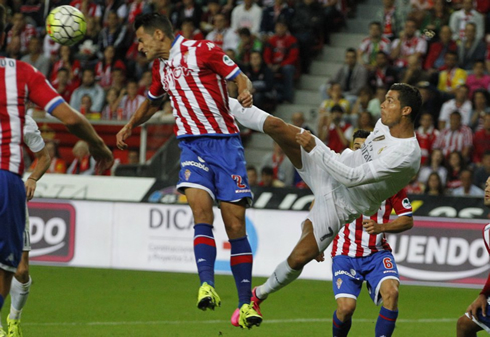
[381,83,422,127]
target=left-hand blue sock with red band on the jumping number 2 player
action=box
[194,223,216,287]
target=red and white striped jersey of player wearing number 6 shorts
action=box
[332,189,412,257]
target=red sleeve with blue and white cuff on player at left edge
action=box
[23,62,65,114]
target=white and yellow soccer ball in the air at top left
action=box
[46,6,87,46]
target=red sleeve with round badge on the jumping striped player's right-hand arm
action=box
[199,41,241,81]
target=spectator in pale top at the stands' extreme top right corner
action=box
[449,0,485,41]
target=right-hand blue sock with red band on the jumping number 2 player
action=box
[230,236,253,308]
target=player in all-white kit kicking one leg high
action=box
[232,83,422,316]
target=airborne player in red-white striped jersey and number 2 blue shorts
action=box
[117,13,262,328]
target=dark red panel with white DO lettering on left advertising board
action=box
[28,201,76,262]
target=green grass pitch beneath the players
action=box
[8,266,478,337]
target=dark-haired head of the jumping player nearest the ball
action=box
[134,13,174,60]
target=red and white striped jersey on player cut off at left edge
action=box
[0,57,64,175]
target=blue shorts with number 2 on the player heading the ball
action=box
[177,136,252,204]
